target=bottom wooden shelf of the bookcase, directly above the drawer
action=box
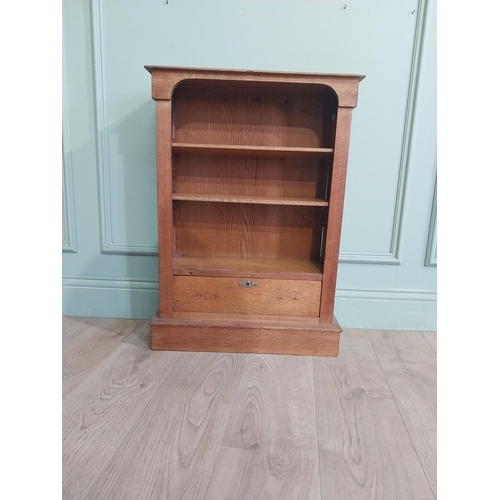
[173,257,322,281]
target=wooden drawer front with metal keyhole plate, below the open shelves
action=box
[174,276,321,316]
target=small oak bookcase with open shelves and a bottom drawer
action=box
[146,66,364,356]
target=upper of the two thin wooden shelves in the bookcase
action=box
[172,142,333,158]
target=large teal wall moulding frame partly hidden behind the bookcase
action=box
[91,0,428,265]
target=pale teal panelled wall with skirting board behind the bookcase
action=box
[62,0,437,329]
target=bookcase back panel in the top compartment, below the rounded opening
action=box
[173,82,336,148]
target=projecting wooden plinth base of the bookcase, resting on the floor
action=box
[150,317,342,356]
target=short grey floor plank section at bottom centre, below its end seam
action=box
[206,447,321,500]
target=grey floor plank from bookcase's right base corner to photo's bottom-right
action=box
[314,338,433,500]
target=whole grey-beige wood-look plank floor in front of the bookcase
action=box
[62,317,437,500]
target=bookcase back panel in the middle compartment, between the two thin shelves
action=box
[173,154,331,199]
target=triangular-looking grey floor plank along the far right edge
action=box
[368,330,437,495]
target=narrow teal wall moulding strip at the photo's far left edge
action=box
[62,38,78,253]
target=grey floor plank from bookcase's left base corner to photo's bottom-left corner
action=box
[62,325,182,500]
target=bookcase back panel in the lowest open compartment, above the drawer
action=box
[174,201,325,261]
